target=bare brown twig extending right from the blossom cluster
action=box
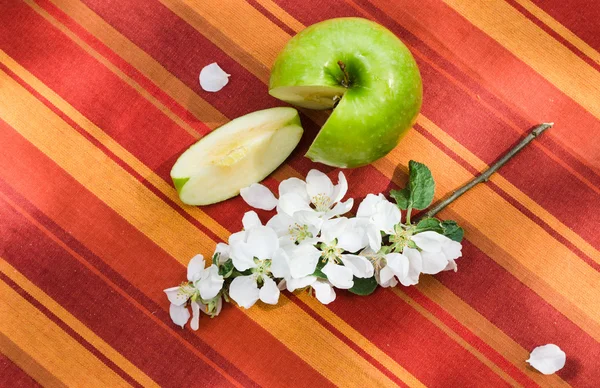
[419,123,554,219]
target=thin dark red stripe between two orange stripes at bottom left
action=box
[0,272,141,387]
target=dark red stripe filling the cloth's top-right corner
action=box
[532,0,600,51]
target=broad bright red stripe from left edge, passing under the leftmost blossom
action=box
[0,120,325,385]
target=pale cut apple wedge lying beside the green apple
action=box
[171,107,303,205]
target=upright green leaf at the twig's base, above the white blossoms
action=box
[390,160,435,210]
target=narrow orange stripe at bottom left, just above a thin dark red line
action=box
[0,257,158,387]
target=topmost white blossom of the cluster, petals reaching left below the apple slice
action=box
[240,170,354,226]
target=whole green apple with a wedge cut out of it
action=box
[269,18,423,167]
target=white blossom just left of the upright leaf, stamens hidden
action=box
[356,194,401,252]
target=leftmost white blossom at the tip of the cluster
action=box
[164,255,224,330]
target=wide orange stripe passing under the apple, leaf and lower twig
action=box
[170,0,600,338]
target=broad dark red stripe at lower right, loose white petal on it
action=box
[437,241,600,387]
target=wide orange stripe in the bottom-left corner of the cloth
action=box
[0,272,129,387]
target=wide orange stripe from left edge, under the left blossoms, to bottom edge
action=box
[0,66,404,386]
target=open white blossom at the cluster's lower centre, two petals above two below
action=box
[319,217,374,289]
